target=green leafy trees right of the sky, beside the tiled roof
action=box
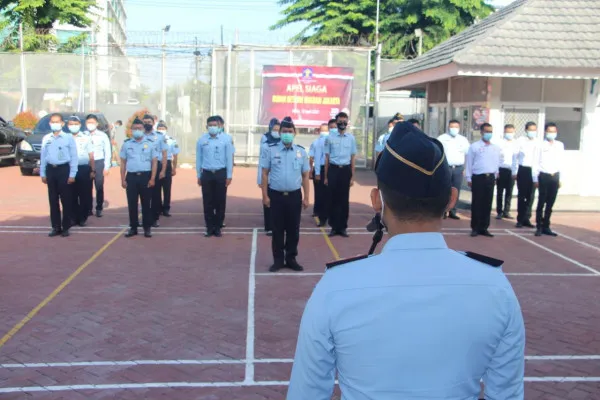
[271,0,493,58]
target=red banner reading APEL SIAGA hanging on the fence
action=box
[258,65,354,127]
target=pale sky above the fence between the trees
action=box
[125,0,512,44]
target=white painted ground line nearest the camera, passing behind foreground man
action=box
[0,376,600,393]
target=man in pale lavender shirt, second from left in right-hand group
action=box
[465,122,502,237]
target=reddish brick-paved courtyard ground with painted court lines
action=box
[0,167,600,400]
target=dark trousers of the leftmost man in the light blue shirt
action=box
[46,163,73,231]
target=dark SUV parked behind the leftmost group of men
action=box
[17,112,108,175]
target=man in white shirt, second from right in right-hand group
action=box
[516,122,539,228]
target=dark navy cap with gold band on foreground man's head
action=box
[375,122,452,198]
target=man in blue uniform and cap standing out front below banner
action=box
[260,117,310,272]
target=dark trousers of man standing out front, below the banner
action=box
[269,189,302,265]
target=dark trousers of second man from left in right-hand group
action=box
[471,174,496,232]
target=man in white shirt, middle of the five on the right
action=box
[496,124,518,219]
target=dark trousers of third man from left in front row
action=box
[201,168,227,232]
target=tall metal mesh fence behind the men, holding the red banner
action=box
[0,44,371,166]
